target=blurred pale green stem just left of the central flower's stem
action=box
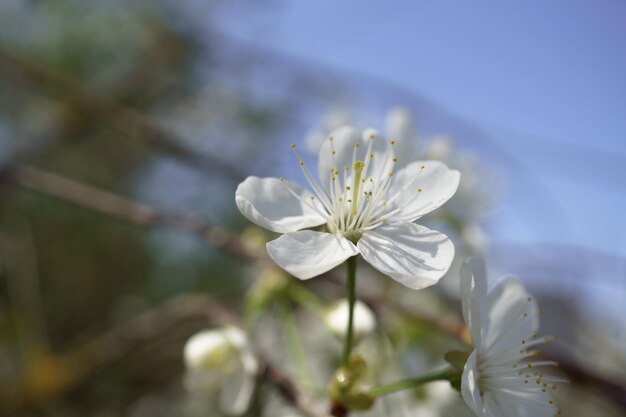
[276,302,313,387]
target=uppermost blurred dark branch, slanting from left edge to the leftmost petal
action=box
[0,49,245,181]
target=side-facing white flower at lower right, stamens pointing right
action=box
[461,258,563,417]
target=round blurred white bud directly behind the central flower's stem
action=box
[324,299,376,344]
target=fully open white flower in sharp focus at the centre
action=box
[235,127,459,289]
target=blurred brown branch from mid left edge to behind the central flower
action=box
[4,165,259,262]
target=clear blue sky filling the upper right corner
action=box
[214,0,626,256]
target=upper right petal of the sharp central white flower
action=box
[389,161,461,222]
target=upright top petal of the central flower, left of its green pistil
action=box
[317,126,361,185]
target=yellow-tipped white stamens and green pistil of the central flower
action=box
[281,134,425,241]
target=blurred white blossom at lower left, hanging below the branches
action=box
[184,326,259,415]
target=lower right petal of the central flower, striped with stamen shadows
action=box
[357,223,454,290]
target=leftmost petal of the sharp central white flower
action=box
[235,176,326,233]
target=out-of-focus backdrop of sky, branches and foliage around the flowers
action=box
[0,0,626,417]
